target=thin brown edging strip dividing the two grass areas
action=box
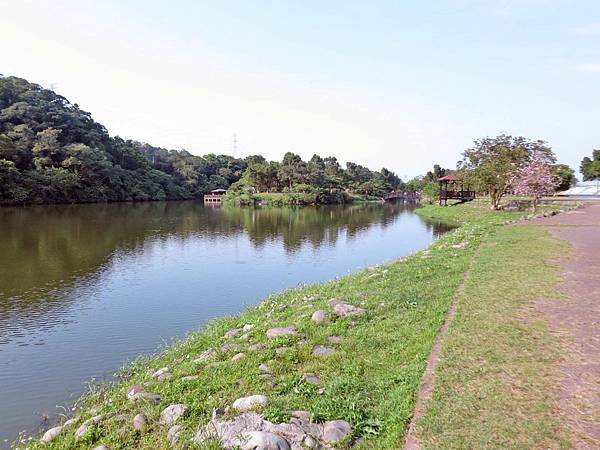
[404,249,479,450]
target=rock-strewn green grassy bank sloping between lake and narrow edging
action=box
[17,202,572,448]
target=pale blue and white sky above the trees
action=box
[0,0,600,179]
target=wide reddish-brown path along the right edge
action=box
[528,201,600,449]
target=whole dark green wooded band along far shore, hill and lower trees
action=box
[0,75,405,204]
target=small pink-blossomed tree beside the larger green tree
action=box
[510,151,560,212]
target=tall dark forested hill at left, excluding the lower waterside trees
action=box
[0,77,251,204]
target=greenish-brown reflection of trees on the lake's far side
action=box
[0,202,447,342]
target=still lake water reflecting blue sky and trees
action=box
[0,202,447,447]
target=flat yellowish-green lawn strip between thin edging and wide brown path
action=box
[418,205,570,449]
